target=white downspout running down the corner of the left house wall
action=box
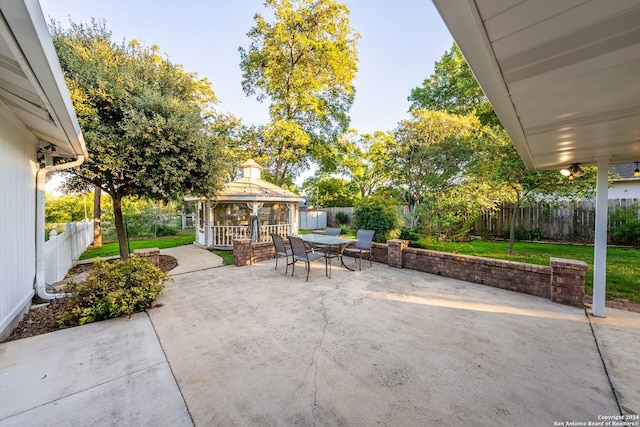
[35,154,85,300]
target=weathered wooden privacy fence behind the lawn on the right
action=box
[473,199,640,243]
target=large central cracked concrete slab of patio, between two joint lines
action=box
[150,262,619,426]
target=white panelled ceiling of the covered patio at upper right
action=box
[433,0,640,170]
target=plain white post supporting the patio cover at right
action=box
[592,157,609,317]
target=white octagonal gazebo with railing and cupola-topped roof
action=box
[189,160,305,249]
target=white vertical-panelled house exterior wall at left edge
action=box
[0,105,38,340]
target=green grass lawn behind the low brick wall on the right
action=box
[418,238,640,302]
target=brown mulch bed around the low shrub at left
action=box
[6,255,178,341]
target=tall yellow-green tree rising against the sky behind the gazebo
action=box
[239,0,359,184]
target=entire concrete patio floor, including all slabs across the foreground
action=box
[0,246,640,426]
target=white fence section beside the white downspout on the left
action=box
[44,220,93,285]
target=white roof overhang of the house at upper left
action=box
[0,0,87,159]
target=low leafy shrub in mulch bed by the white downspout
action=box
[59,257,172,325]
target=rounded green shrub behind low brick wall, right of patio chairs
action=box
[353,196,400,243]
